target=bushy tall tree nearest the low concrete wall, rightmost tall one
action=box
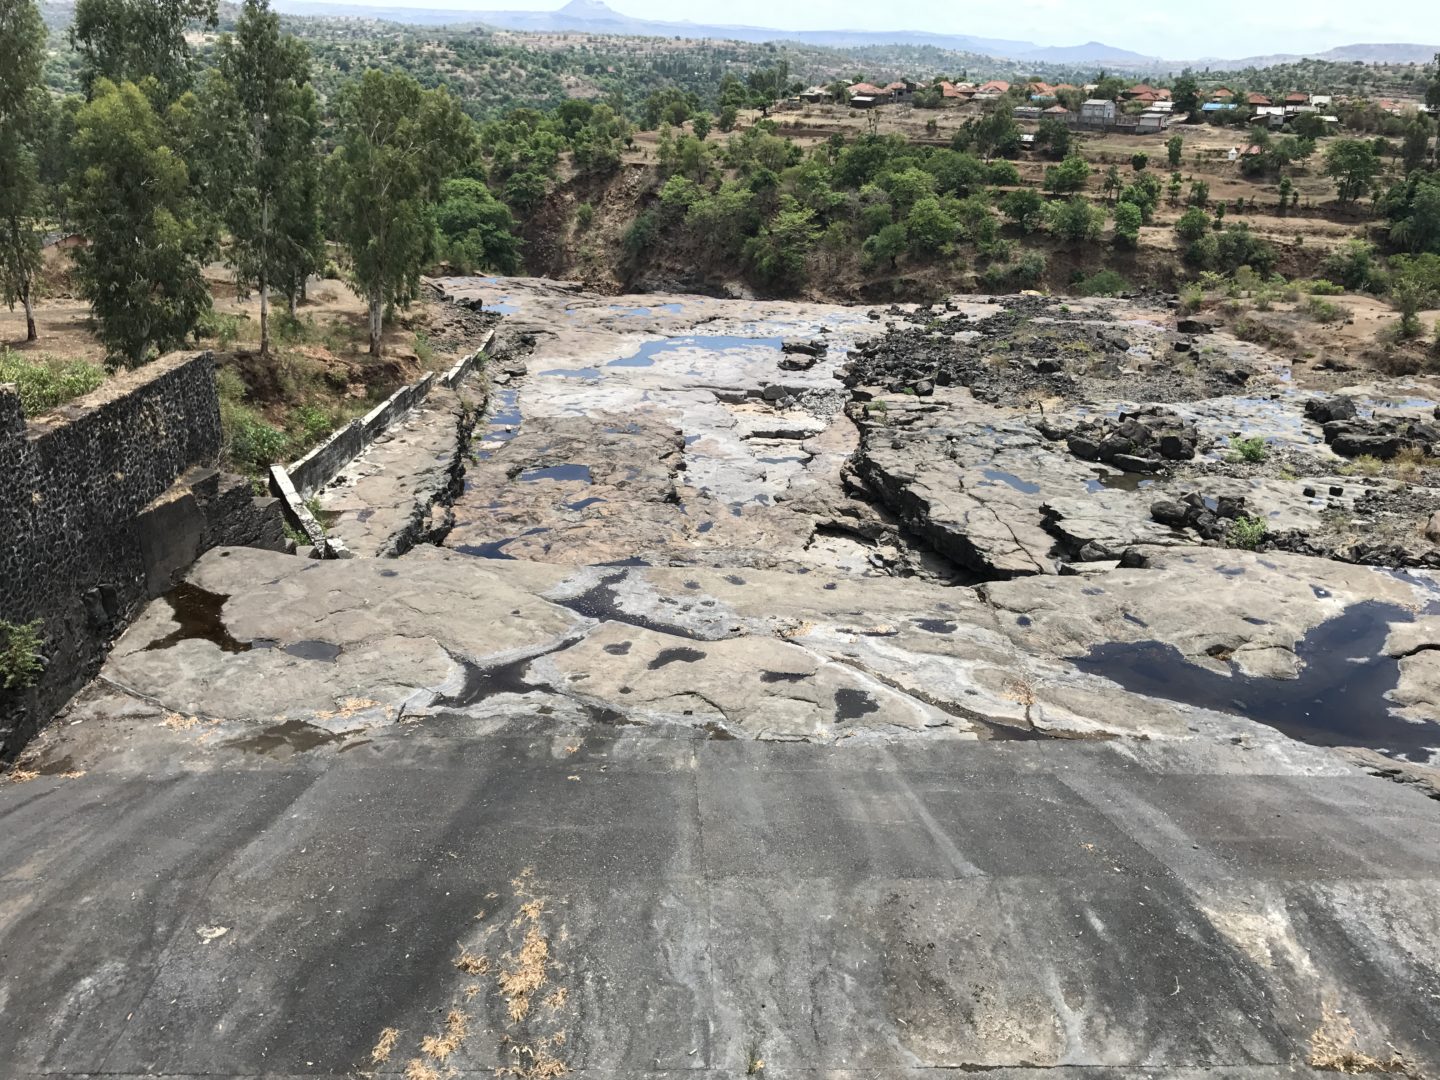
[330,71,475,356]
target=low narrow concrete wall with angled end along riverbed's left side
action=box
[271,330,495,559]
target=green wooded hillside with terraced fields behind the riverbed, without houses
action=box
[8,0,1440,432]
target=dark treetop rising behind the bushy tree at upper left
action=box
[71,0,219,102]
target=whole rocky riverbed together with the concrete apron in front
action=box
[0,279,1440,1080]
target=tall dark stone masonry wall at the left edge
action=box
[0,353,284,757]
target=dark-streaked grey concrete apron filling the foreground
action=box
[0,729,1440,1077]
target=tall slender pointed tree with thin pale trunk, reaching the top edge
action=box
[204,0,318,356]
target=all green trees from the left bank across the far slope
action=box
[0,0,1440,366]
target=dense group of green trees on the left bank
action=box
[0,0,625,366]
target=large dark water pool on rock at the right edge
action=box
[1074,600,1440,762]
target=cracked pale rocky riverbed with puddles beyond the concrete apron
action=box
[33,279,1440,765]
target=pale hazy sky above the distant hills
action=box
[306,0,1440,59]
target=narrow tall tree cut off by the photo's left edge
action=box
[0,0,46,341]
